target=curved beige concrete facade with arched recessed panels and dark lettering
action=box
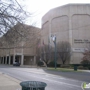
[42,4,90,64]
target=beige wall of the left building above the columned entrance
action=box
[0,25,41,56]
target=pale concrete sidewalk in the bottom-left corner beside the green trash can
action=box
[0,72,21,90]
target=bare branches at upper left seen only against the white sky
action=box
[0,0,28,34]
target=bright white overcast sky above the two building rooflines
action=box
[18,0,90,27]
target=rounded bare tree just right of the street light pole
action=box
[57,41,71,64]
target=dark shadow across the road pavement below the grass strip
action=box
[43,69,90,83]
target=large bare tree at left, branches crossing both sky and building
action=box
[0,0,39,64]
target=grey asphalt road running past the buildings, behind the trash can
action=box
[0,65,90,90]
